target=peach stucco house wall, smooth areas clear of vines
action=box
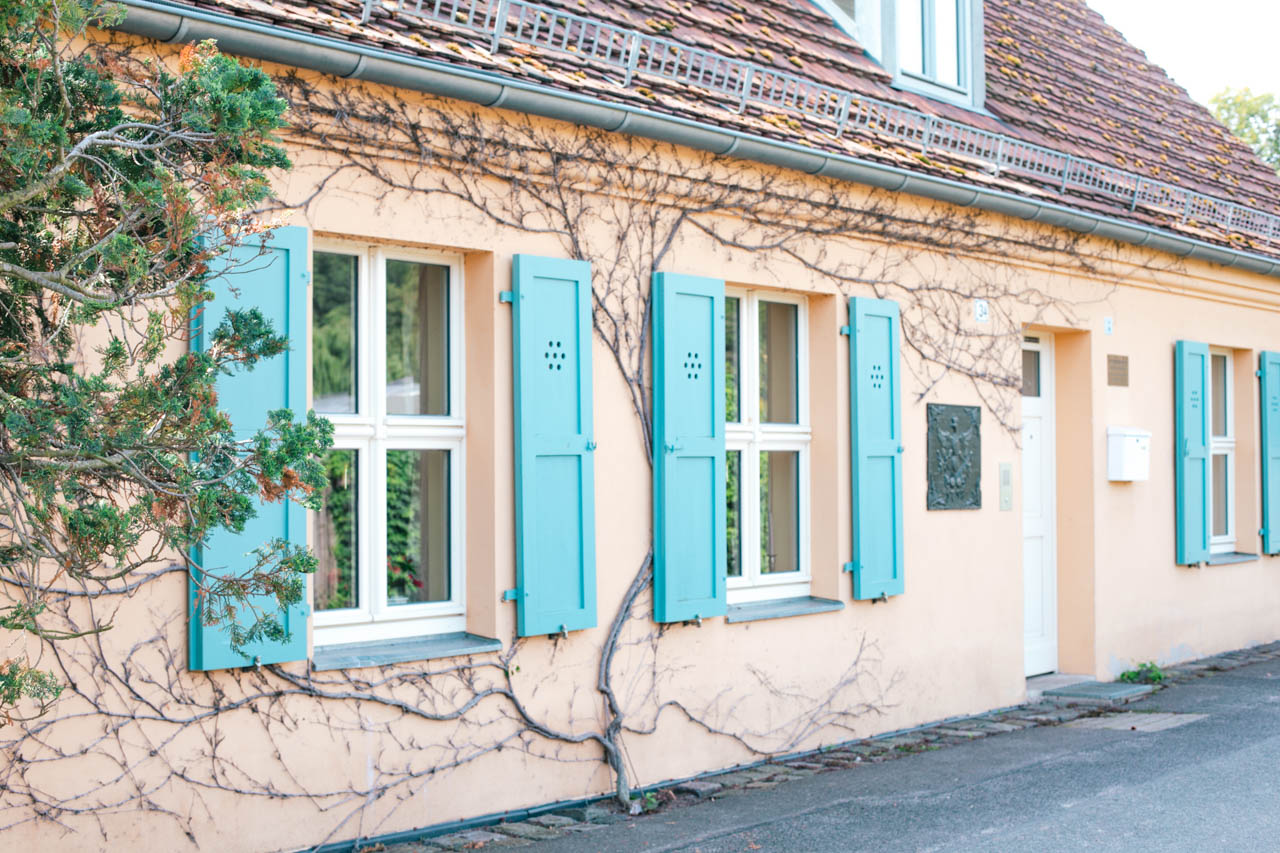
[10,56,1280,850]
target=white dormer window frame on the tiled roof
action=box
[813,0,987,110]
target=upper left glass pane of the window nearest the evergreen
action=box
[311,252,360,415]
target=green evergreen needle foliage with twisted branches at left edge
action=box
[0,0,332,725]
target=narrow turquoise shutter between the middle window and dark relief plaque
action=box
[849,297,904,599]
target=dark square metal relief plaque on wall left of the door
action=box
[927,403,982,510]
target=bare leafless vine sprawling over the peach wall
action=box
[0,61,1152,845]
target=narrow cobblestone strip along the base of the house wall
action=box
[357,643,1280,853]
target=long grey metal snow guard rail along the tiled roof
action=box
[361,0,1280,249]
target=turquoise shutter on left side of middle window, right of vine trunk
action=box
[653,273,727,622]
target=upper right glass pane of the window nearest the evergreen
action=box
[387,260,449,415]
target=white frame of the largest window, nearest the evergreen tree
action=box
[307,240,466,647]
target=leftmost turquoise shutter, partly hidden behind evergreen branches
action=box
[188,227,308,670]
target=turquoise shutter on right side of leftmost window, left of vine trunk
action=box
[512,255,595,637]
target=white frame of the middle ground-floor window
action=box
[724,288,813,605]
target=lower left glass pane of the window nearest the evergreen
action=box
[312,450,360,610]
